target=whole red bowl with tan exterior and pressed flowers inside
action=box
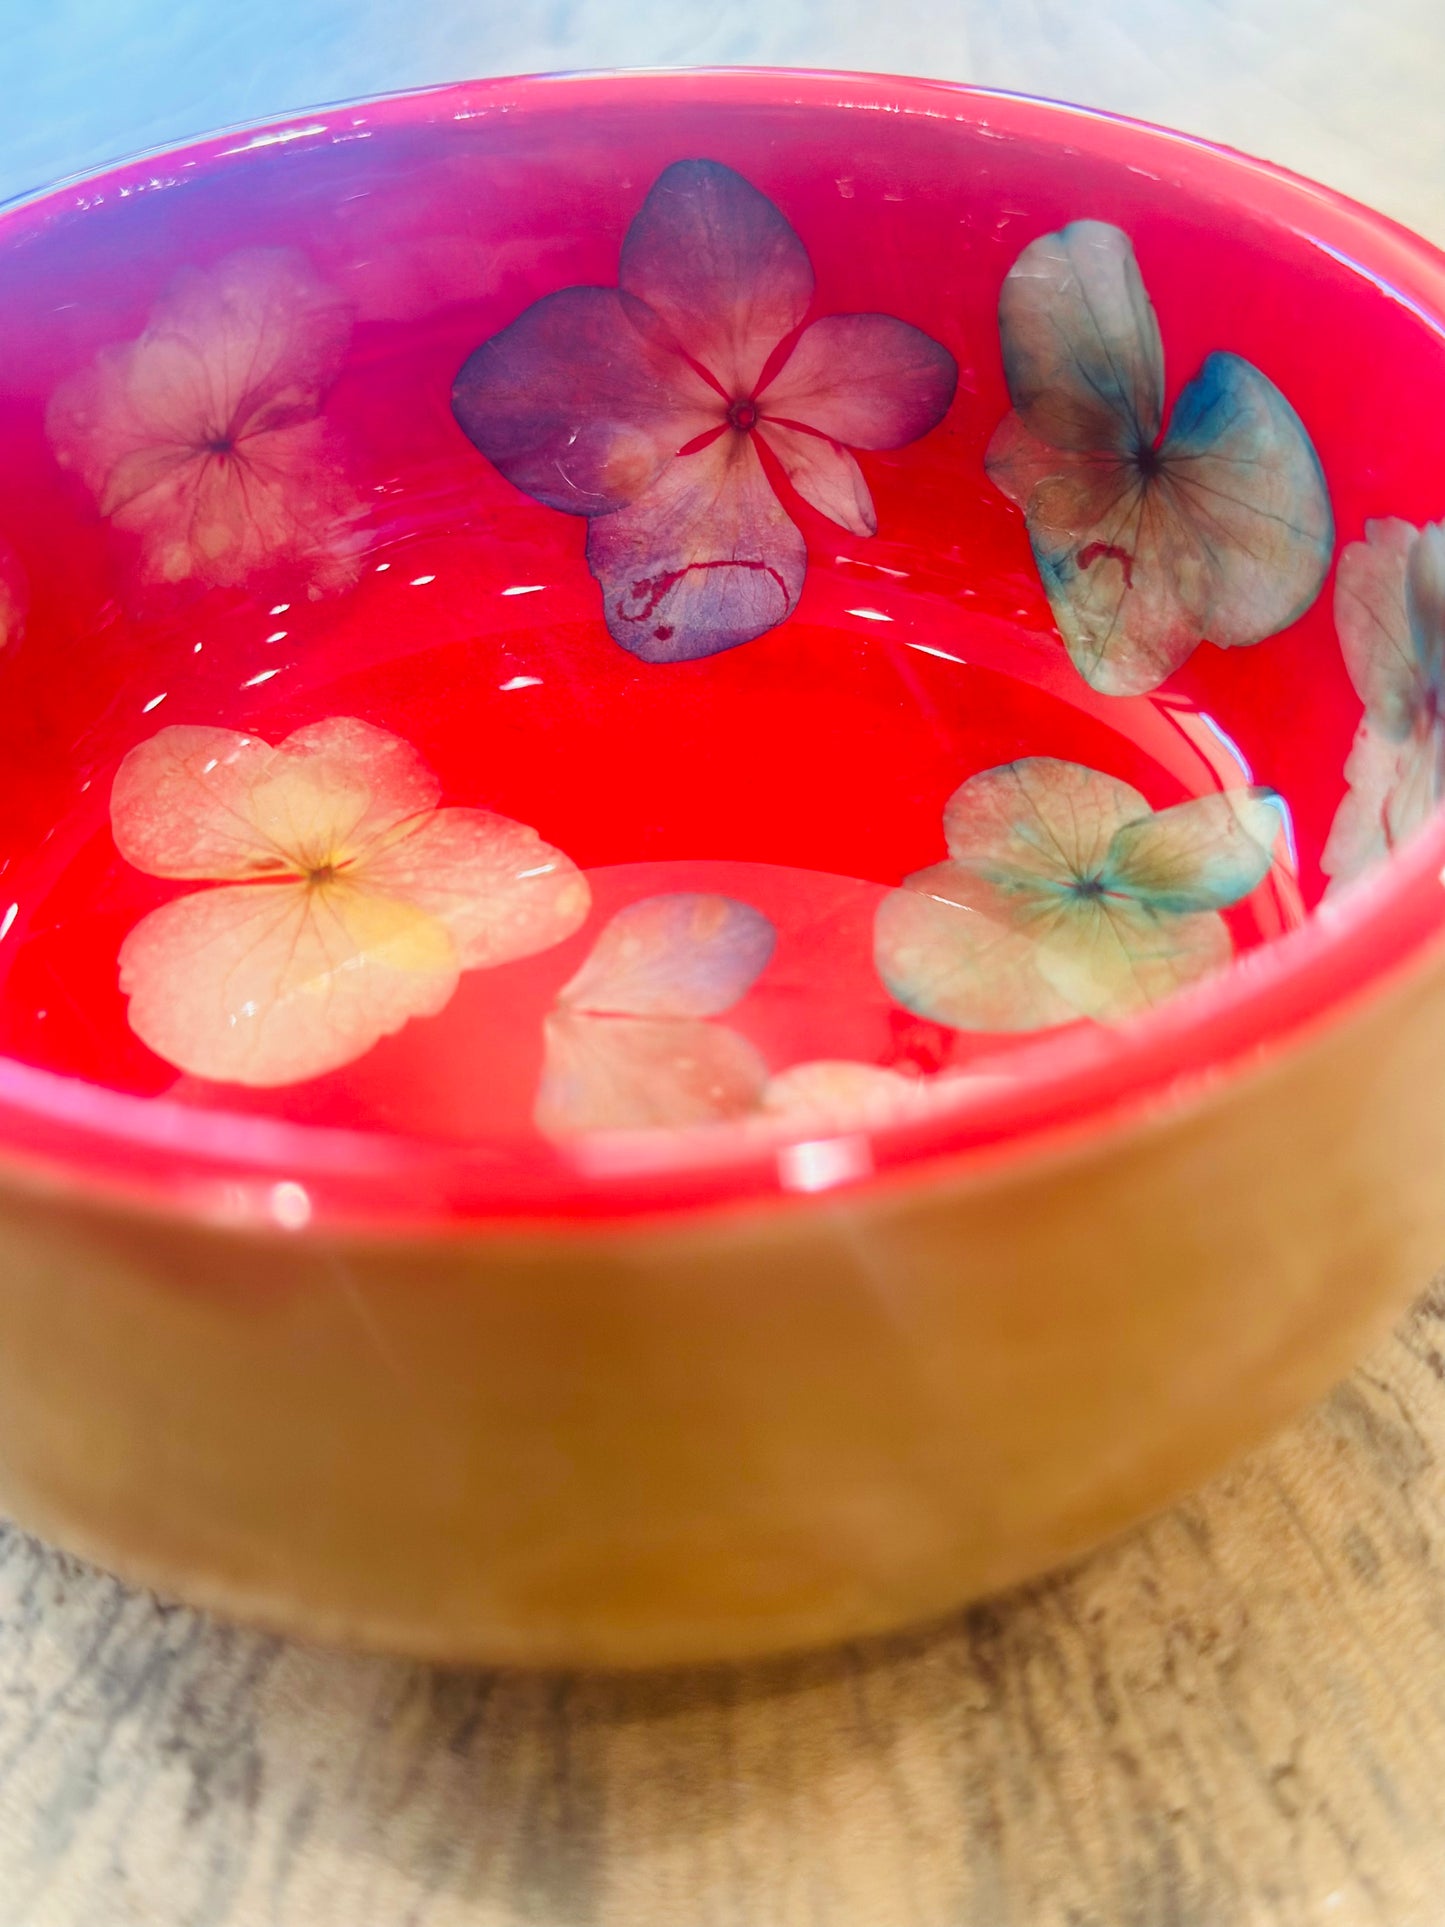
[0,71,1445,1665]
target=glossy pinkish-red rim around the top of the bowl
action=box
[0,67,1445,1241]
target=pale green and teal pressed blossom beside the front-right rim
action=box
[875,757,1281,1031]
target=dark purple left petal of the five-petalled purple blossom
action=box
[451,287,723,515]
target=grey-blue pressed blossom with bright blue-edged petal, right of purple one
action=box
[986,222,1333,696]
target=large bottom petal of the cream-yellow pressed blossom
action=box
[119,883,459,1087]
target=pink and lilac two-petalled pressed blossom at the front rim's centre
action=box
[536,890,776,1137]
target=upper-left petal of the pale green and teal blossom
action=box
[944,755,1148,902]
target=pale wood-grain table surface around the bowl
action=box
[0,0,1445,1927]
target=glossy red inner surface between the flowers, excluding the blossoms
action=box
[0,73,1445,1227]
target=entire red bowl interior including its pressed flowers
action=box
[0,75,1445,1222]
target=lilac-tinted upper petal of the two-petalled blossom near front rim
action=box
[559,890,776,1017]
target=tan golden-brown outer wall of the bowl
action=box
[0,936,1445,1667]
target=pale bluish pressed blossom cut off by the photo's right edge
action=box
[1320,518,1445,884]
